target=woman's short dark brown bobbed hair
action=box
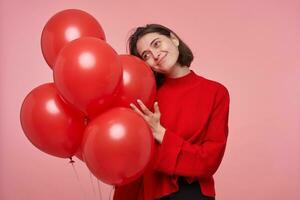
[128,24,194,88]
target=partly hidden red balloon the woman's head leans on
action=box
[114,55,156,109]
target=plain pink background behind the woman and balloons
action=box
[0,0,300,200]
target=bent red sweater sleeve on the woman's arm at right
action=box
[154,86,229,177]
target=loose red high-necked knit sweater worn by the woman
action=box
[114,70,229,200]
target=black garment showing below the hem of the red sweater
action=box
[160,177,215,200]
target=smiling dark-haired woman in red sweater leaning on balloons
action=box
[114,24,229,200]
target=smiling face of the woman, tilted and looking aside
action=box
[136,33,179,74]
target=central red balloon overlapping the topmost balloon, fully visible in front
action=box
[53,37,122,118]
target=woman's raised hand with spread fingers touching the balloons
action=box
[130,99,166,143]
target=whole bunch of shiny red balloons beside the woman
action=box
[20,9,156,186]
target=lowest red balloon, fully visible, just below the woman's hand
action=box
[83,107,154,185]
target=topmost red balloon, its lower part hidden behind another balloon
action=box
[41,9,105,68]
